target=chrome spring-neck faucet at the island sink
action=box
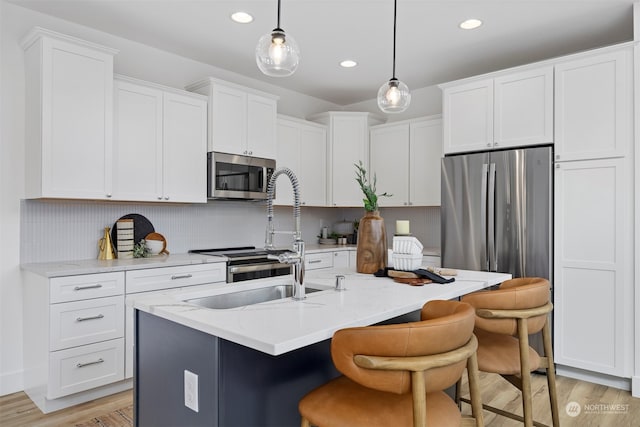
[264,168,306,300]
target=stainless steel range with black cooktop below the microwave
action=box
[189,246,291,283]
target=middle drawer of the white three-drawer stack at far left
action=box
[49,295,124,351]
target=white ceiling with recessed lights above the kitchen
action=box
[11,0,634,105]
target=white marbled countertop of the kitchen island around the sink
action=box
[132,269,511,356]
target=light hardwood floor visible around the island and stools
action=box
[0,372,640,427]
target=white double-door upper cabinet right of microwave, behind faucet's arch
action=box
[275,116,327,206]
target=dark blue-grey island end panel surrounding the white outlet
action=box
[134,310,219,427]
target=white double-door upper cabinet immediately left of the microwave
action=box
[113,77,207,203]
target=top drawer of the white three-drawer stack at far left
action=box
[49,271,124,303]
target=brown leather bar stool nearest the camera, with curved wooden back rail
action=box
[298,301,484,427]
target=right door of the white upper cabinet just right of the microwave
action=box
[298,125,327,206]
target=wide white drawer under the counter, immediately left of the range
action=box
[127,262,227,294]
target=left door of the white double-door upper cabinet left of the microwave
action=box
[113,80,162,201]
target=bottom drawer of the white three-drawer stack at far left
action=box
[47,338,124,399]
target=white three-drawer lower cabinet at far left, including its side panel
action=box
[23,272,125,413]
